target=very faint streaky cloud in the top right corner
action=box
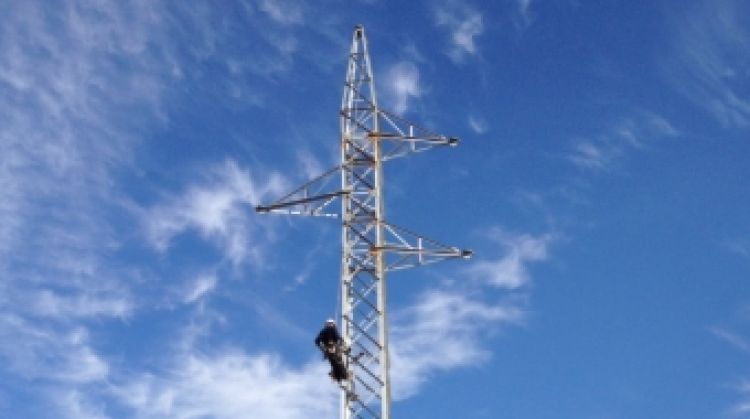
[661,0,750,128]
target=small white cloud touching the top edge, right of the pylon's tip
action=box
[435,2,484,63]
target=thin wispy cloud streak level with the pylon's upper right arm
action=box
[566,111,681,171]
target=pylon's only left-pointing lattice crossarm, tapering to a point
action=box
[255,166,349,217]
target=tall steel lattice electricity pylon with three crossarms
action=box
[256,25,471,419]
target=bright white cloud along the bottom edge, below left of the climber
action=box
[115,350,338,419]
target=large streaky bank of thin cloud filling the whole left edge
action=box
[0,1,175,417]
